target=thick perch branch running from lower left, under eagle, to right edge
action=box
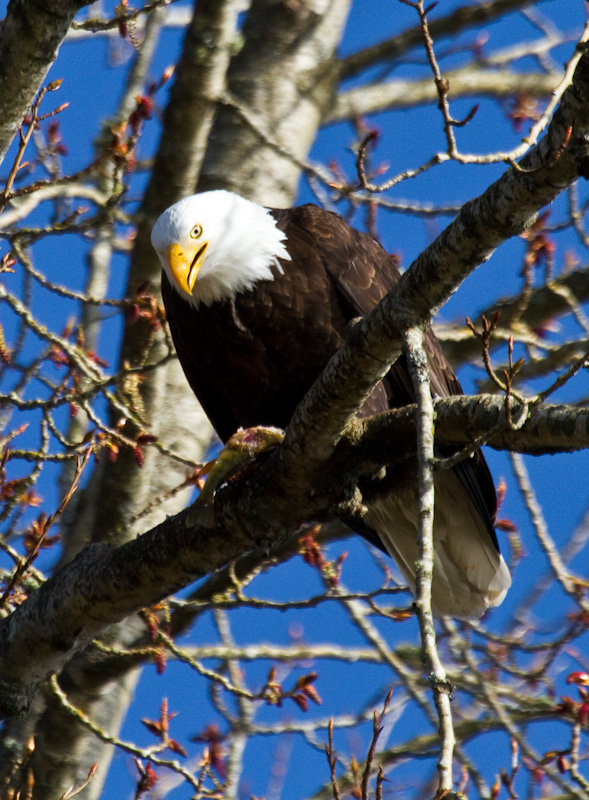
[0,397,589,716]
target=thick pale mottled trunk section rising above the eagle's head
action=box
[198,0,350,208]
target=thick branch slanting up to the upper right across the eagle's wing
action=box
[268,39,589,488]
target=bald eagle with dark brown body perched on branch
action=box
[151,191,511,618]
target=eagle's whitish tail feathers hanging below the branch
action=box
[364,470,511,619]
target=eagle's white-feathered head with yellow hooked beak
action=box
[151,190,290,307]
